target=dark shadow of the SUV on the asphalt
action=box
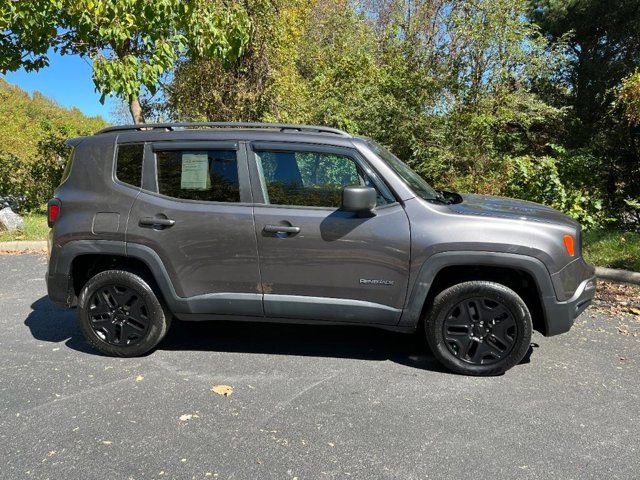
[24,297,533,373]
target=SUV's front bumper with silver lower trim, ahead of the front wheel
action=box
[543,275,596,337]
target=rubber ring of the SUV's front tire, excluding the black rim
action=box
[425,281,532,375]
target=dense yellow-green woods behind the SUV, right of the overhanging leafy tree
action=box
[163,0,640,226]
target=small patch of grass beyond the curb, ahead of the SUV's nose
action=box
[583,230,640,272]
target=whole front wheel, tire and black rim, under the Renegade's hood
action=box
[424,281,532,375]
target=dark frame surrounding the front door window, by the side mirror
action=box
[246,141,398,208]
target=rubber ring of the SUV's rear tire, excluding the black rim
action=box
[78,270,168,357]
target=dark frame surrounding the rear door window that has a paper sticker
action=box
[142,140,253,206]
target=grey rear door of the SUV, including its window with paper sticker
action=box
[127,141,263,316]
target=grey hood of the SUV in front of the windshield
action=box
[449,194,579,227]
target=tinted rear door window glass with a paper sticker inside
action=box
[156,150,240,202]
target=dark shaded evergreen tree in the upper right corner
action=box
[531,0,640,224]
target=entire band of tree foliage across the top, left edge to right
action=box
[0,0,640,226]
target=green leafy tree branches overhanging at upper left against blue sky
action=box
[0,0,249,123]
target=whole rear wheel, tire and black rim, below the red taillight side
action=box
[78,270,171,357]
